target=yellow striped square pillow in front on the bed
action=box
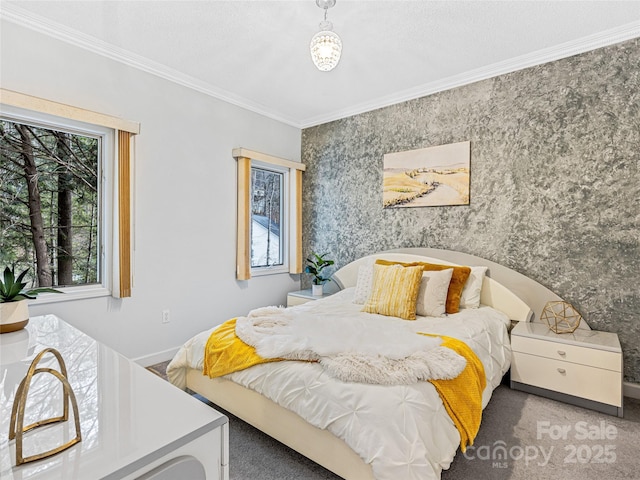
[362,265,423,320]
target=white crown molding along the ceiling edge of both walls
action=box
[0,3,640,129]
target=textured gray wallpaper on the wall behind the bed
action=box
[302,39,640,383]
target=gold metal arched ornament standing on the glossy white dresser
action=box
[9,348,82,466]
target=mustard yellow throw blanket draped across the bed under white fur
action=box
[203,318,486,452]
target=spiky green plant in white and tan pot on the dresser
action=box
[0,267,62,333]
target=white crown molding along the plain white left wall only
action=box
[0,4,300,128]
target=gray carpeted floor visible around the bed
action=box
[148,362,640,480]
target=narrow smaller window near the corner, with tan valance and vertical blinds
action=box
[233,148,304,280]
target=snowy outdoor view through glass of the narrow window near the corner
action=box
[251,167,284,267]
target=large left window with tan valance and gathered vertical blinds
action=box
[0,90,139,303]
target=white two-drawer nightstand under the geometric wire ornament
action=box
[511,322,622,417]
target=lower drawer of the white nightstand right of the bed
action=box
[511,350,622,407]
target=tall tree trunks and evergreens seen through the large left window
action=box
[0,118,101,287]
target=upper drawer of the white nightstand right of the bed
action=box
[511,335,622,372]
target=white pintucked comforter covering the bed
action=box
[167,288,511,480]
